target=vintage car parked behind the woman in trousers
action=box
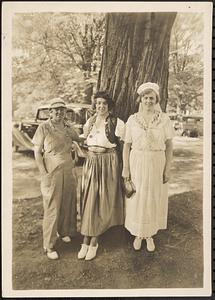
[13,103,93,151]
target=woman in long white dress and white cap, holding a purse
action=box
[122,82,174,251]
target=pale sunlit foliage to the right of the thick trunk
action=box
[168,13,203,113]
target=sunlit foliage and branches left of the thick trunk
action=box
[12,13,104,118]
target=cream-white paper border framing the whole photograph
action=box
[2,1,213,298]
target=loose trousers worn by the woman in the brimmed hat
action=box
[41,162,77,248]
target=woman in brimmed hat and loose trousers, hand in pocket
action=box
[33,98,79,259]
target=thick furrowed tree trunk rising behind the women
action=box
[97,13,176,121]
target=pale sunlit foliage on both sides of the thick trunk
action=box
[12,13,203,118]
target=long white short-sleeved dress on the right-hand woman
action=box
[125,111,174,237]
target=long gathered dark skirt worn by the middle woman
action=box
[81,149,124,236]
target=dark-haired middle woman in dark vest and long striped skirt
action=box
[78,91,124,260]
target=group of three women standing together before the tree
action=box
[33,82,174,260]
